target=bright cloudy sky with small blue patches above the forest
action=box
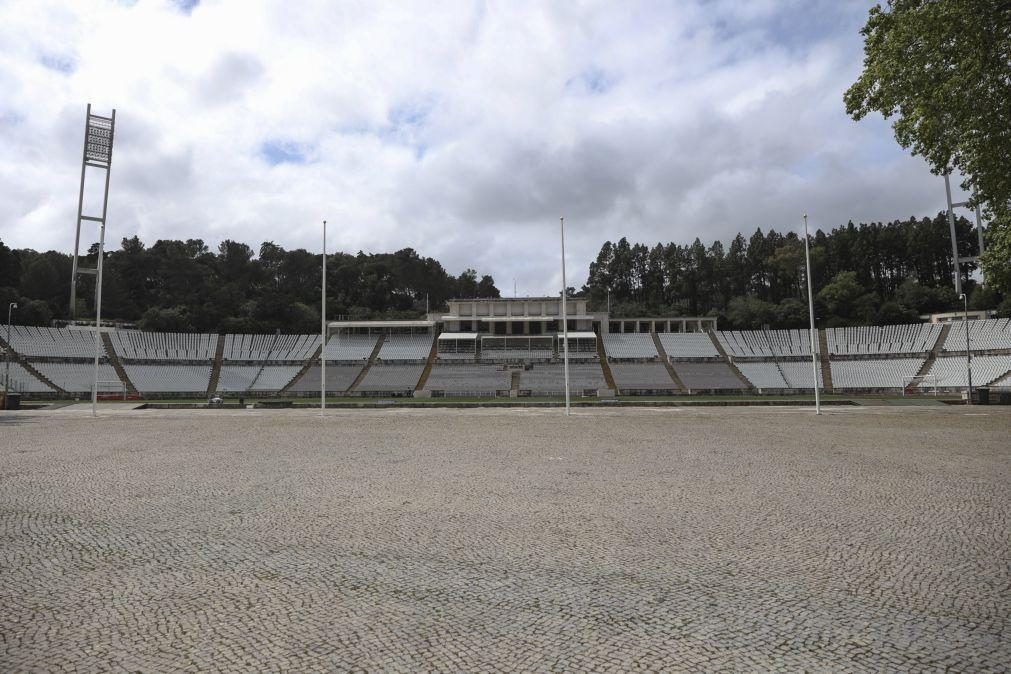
[0,0,962,294]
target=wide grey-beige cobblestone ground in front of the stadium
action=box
[0,408,1011,672]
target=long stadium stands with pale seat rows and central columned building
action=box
[4,297,1011,402]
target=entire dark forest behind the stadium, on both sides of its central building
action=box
[0,213,1011,332]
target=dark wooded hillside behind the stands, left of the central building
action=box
[0,236,498,332]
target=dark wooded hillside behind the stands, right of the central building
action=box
[582,213,1011,328]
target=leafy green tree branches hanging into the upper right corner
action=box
[844,0,1011,291]
